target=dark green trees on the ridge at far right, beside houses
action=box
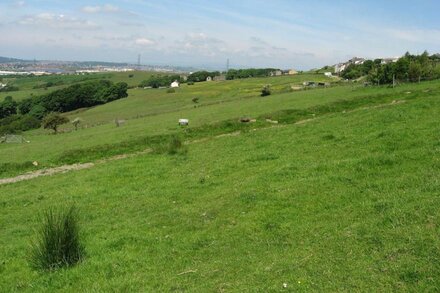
[340,51,440,84]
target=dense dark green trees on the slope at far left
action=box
[0,80,128,134]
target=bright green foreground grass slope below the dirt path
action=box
[0,90,440,292]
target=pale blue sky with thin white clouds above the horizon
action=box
[0,0,440,70]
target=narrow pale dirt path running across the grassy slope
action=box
[0,100,405,185]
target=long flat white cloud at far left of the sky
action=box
[18,13,99,30]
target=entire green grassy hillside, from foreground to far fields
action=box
[0,75,440,292]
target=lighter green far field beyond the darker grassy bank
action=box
[0,76,439,176]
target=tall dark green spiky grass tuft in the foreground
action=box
[30,206,84,270]
